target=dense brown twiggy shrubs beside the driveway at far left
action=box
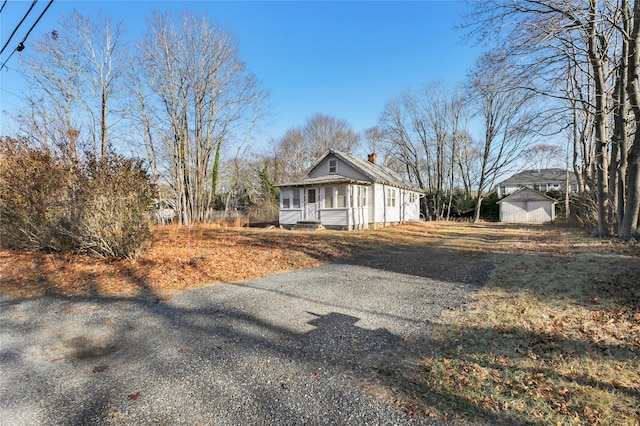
[0,139,154,259]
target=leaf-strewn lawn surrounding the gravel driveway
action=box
[0,222,640,425]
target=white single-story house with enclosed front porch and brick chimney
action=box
[277,150,422,230]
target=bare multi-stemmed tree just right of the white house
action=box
[380,82,472,219]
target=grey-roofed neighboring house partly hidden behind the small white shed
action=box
[496,169,578,198]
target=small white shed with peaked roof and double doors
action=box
[498,188,556,223]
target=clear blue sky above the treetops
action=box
[0,0,479,149]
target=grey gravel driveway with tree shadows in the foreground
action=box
[0,251,492,426]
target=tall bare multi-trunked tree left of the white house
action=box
[139,13,266,224]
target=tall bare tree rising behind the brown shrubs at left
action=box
[19,11,128,161]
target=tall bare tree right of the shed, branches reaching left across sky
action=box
[470,0,635,236]
